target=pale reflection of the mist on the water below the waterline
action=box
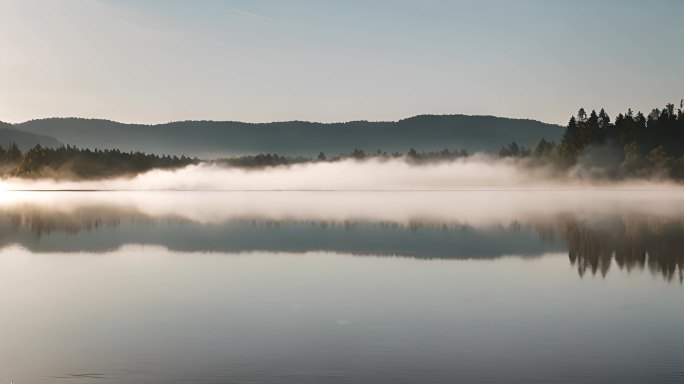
[0,189,684,227]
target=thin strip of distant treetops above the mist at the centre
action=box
[212,148,468,168]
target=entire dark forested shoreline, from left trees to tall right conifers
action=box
[0,100,684,181]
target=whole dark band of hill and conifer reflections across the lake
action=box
[0,206,684,281]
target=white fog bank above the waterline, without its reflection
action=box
[0,155,679,191]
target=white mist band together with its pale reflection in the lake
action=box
[0,155,684,231]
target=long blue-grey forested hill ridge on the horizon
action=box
[14,115,563,158]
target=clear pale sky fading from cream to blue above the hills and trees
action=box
[0,0,684,123]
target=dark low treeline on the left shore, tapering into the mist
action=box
[0,143,199,179]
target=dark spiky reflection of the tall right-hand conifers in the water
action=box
[557,217,684,281]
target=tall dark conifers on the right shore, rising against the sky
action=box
[499,100,684,180]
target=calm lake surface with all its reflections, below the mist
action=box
[0,189,684,384]
